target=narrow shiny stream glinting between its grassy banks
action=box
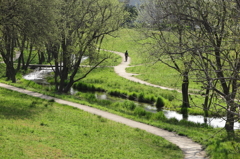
[23,68,240,129]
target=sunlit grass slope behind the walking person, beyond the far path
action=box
[103,29,203,89]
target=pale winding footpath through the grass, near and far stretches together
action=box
[0,51,206,159]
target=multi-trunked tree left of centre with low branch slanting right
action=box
[47,0,125,93]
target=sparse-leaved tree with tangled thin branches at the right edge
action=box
[138,0,240,135]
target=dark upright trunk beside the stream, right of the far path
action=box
[181,72,190,119]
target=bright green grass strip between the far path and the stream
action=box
[76,68,220,115]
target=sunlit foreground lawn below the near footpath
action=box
[0,88,183,159]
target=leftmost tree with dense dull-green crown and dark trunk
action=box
[0,0,55,82]
